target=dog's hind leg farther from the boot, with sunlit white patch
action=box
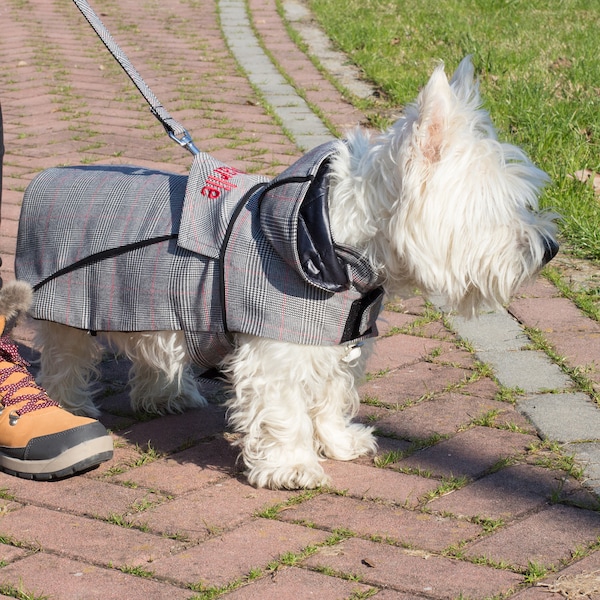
[106,331,206,414]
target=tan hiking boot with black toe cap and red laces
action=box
[0,308,113,480]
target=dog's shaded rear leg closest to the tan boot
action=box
[35,321,102,417]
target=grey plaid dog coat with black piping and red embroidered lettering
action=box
[15,142,383,368]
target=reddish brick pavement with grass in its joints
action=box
[0,0,600,600]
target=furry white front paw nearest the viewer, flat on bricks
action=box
[246,462,329,490]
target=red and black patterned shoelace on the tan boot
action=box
[0,336,58,416]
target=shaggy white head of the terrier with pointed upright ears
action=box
[372,58,558,314]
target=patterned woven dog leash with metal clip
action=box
[73,0,200,155]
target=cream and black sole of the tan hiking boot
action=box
[0,435,113,481]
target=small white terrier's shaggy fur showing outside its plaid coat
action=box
[18,58,558,489]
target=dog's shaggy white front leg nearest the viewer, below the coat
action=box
[225,336,327,489]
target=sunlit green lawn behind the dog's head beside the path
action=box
[309,0,600,259]
